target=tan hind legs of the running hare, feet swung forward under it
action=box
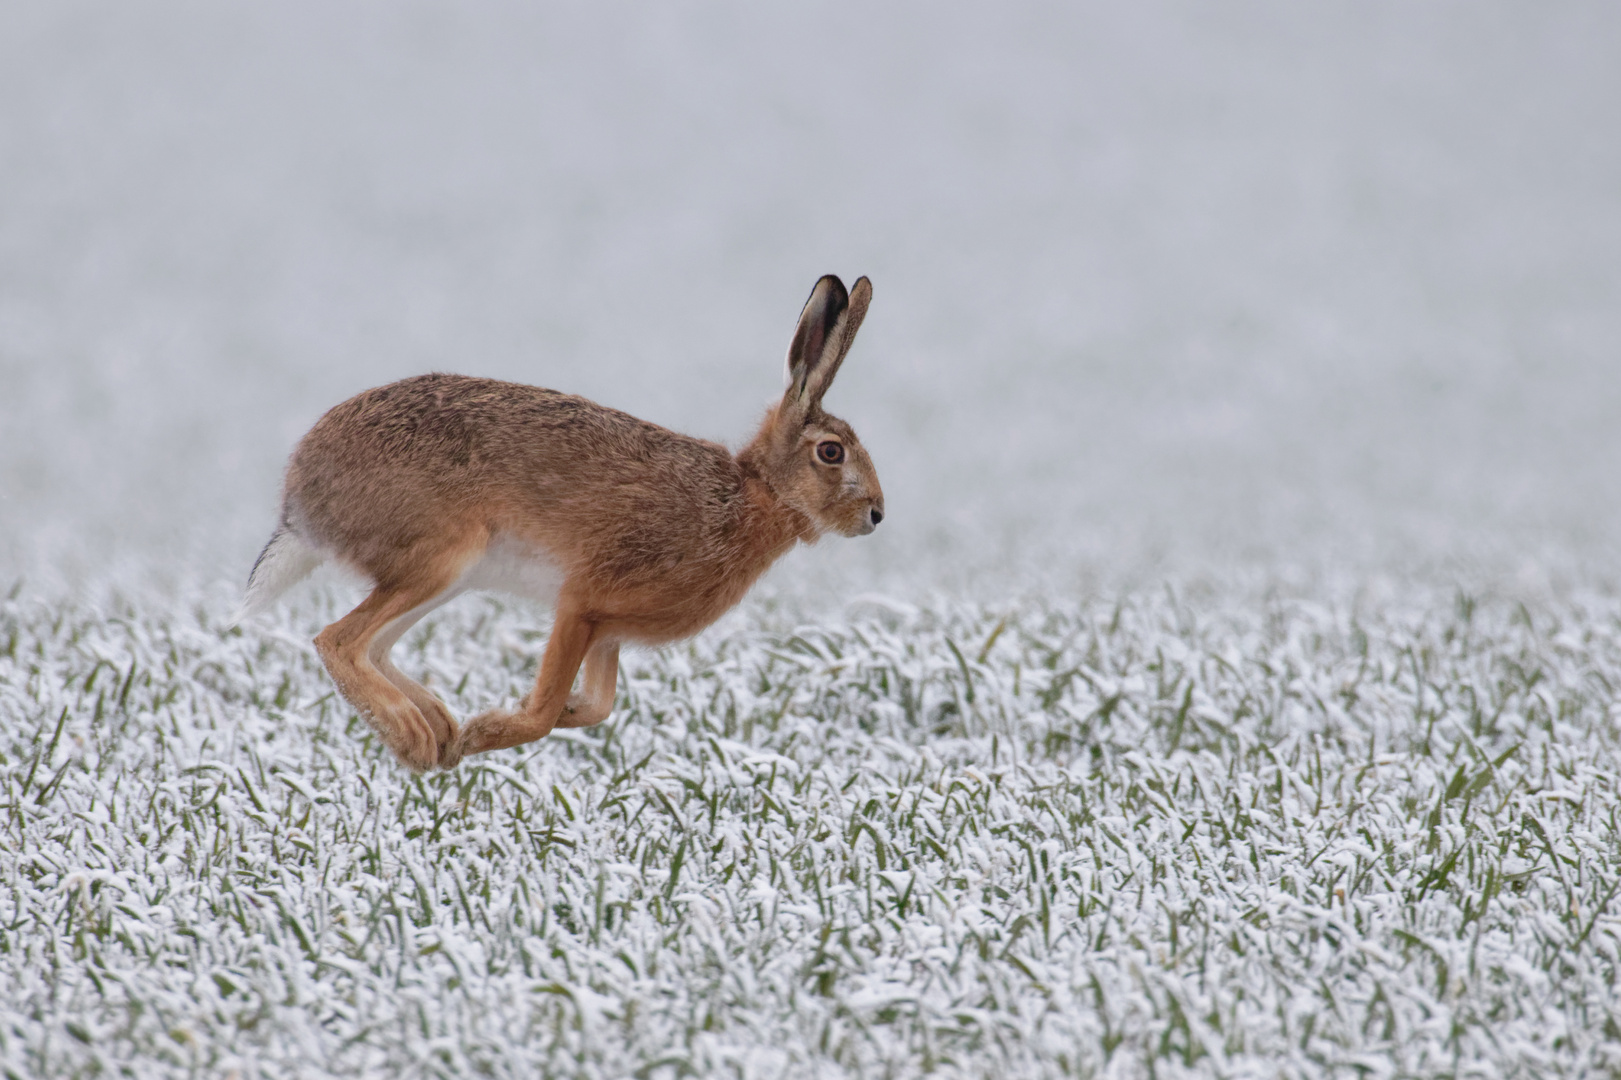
[314,568,457,769]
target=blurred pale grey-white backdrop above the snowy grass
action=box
[0,0,1621,592]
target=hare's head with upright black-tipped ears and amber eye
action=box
[759,274,883,537]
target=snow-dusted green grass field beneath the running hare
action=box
[0,587,1621,1078]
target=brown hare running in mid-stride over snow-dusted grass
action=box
[242,276,883,769]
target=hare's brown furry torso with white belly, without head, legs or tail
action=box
[269,375,817,644]
